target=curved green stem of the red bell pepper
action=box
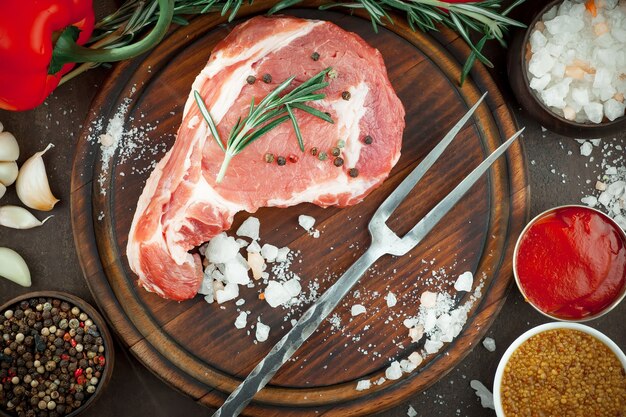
[53,0,174,72]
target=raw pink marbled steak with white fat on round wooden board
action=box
[127,17,404,300]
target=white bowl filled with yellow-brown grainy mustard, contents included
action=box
[493,322,626,417]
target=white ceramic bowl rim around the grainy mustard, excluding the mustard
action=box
[493,322,626,417]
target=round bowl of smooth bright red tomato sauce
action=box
[513,205,626,322]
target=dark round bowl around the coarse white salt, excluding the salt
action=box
[507,0,626,139]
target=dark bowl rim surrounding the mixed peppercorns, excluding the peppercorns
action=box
[0,291,115,417]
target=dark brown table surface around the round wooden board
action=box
[0,0,626,417]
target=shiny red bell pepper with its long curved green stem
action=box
[0,0,174,110]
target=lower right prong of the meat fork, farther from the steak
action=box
[401,127,525,253]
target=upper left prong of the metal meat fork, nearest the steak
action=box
[373,93,487,221]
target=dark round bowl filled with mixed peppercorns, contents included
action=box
[0,291,113,417]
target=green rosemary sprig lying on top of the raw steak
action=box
[194,68,333,183]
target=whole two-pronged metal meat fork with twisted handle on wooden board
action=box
[213,93,524,417]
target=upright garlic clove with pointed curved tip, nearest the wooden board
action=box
[15,144,59,211]
